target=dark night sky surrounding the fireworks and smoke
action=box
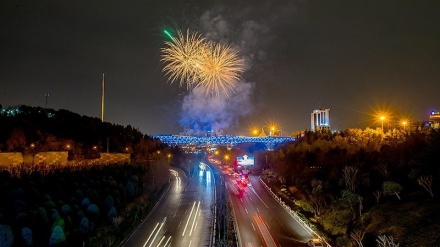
[0,0,440,135]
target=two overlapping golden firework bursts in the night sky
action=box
[161,30,243,96]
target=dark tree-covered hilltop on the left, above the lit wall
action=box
[0,105,164,161]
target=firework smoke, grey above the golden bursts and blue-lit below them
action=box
[179,11,268,136]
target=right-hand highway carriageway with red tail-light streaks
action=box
[227,175,316,247]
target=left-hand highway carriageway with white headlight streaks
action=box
[121,167,214,247]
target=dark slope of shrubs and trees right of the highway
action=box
[266,129,440,246]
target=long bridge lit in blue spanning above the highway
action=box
[153,135,295,149]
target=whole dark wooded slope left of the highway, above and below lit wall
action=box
[0,106,194,247]
